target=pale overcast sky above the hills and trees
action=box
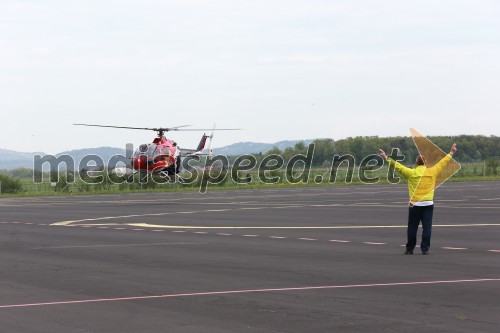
[0,0,500,153]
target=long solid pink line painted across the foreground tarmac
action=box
[0,279,500,309]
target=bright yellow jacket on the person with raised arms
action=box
[387,154,453,203]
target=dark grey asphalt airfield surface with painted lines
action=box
[0,182,500,332]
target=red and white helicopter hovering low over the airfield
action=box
[73,124,239,177]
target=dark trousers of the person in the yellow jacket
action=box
[406,205,434,252]
